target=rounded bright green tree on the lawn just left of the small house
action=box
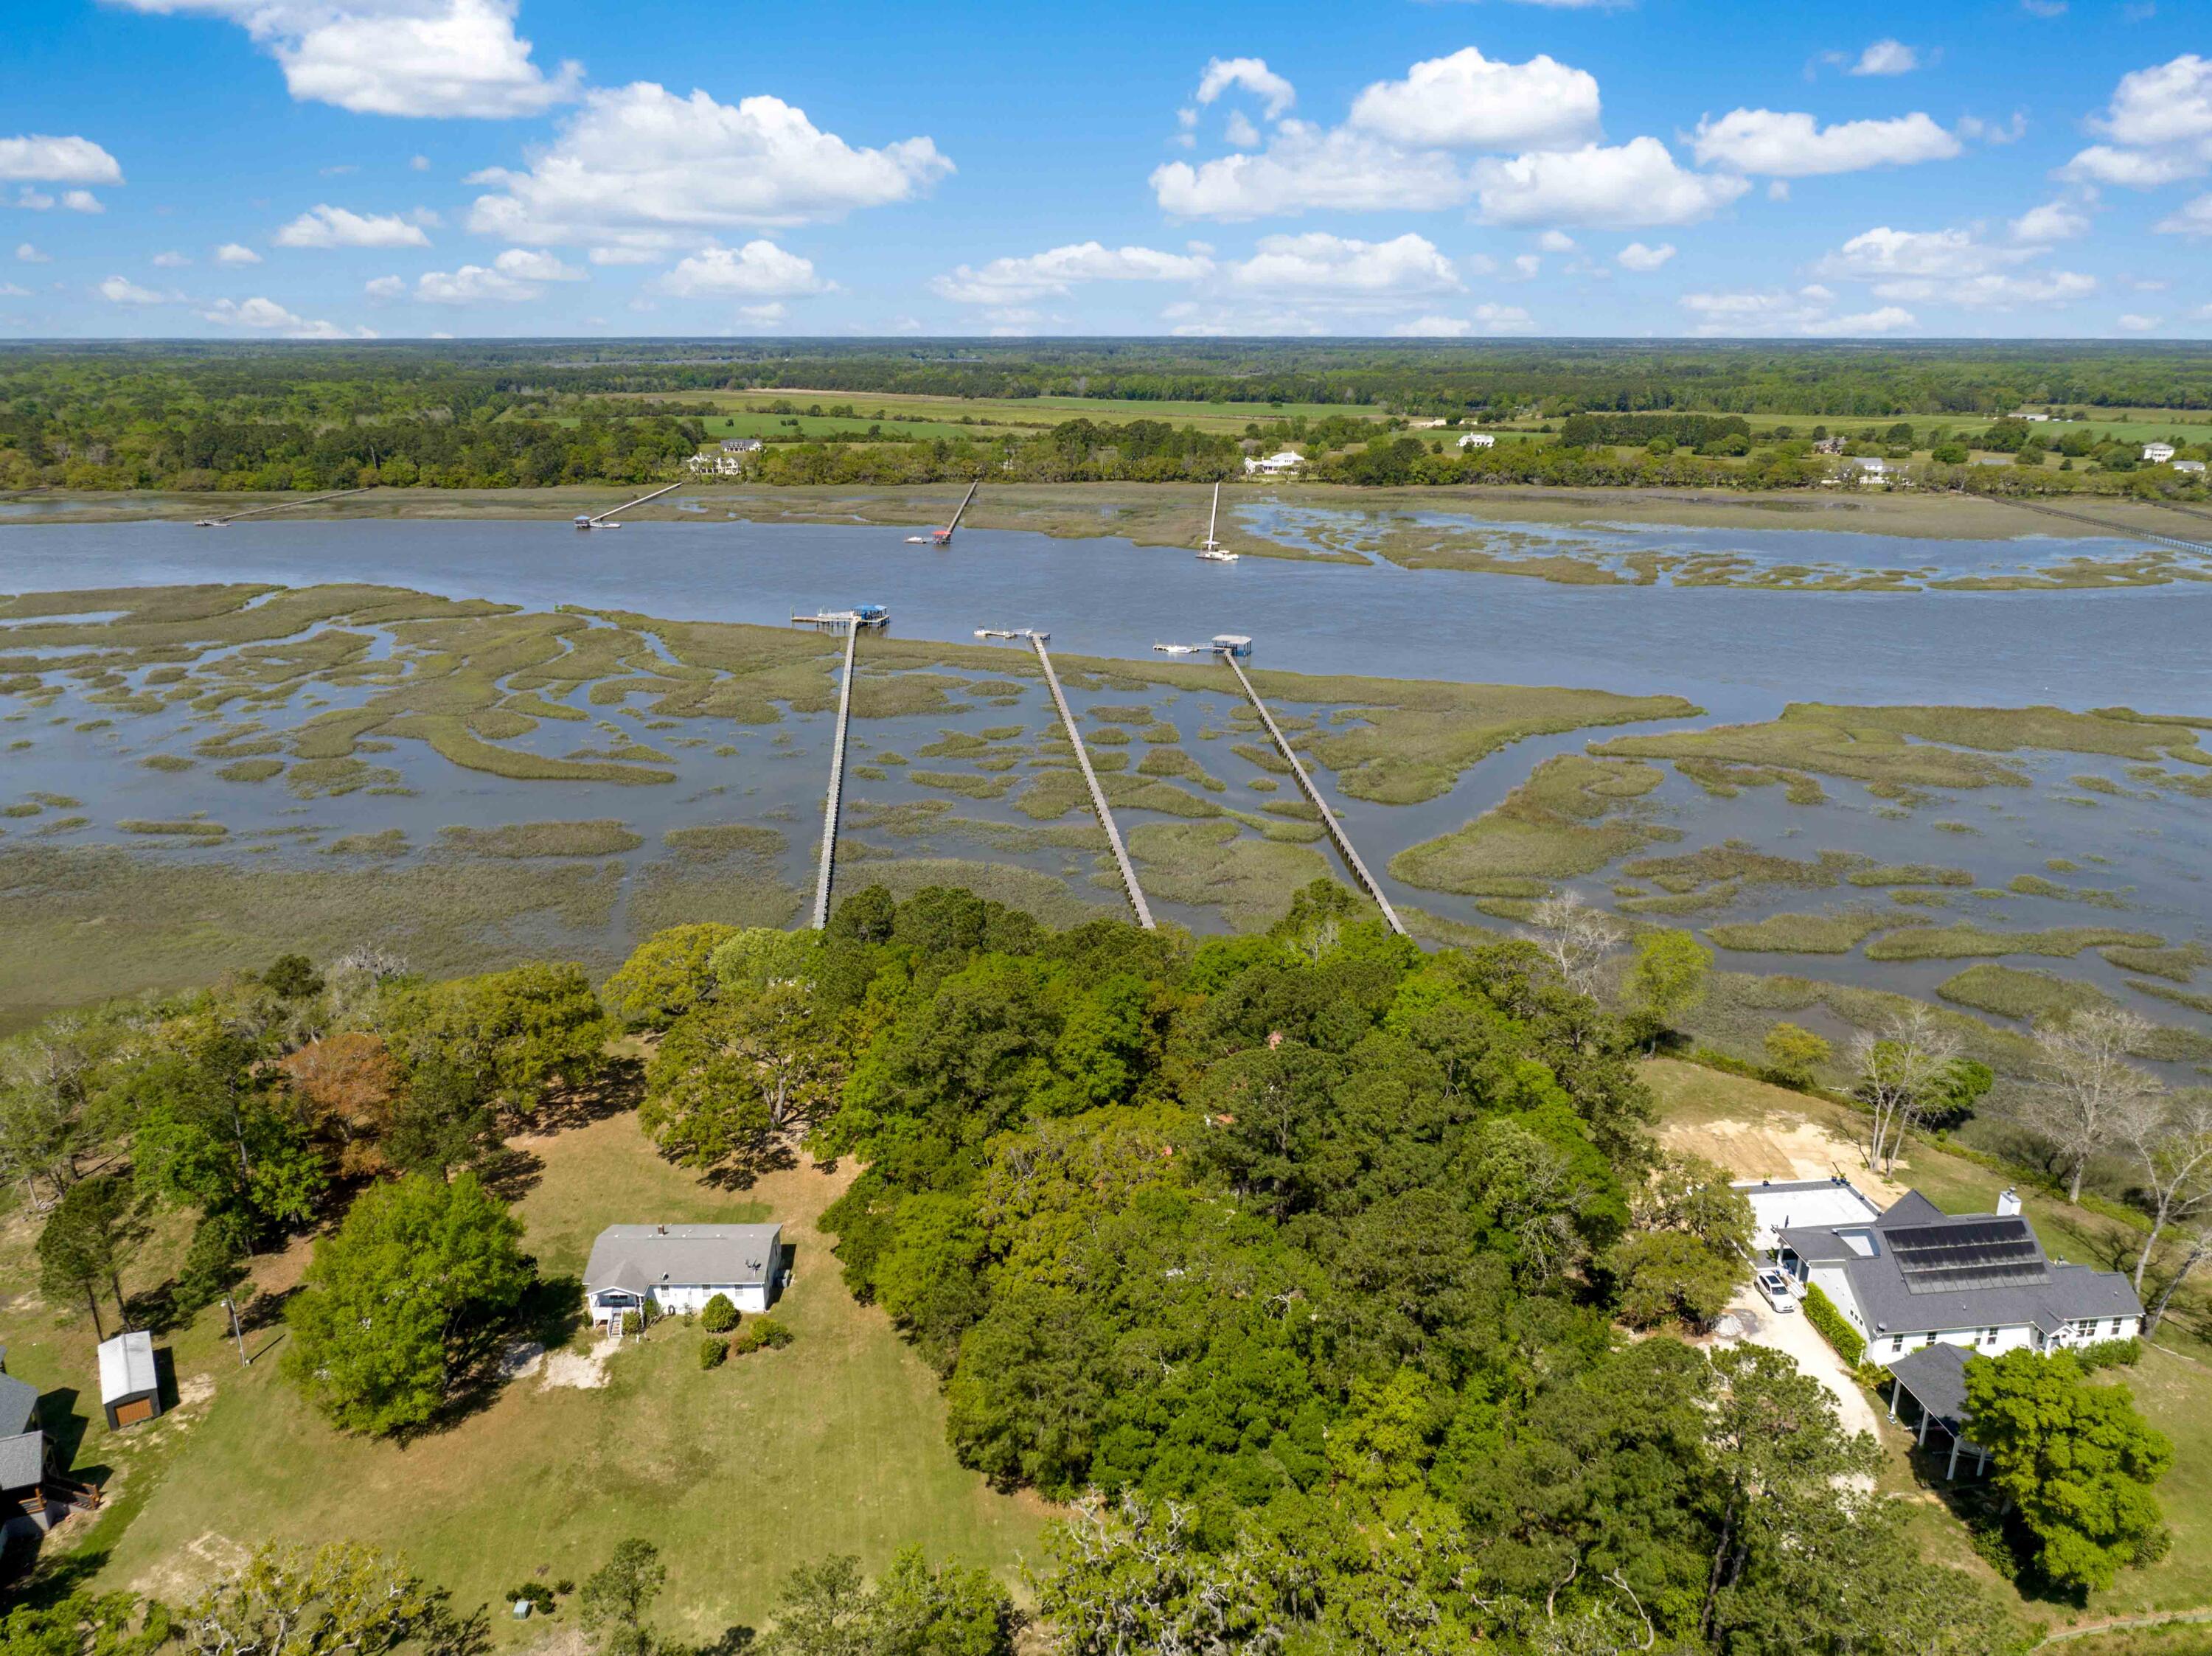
[285,1172,535,1435]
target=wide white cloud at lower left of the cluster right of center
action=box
[1150,122,1469,221]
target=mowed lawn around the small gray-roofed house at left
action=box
[60,1114,1046,1641]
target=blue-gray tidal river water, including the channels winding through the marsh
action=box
[0,518,2212,1065]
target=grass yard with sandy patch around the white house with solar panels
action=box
[1641,1059,2212,1627]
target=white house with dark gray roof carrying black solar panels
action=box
[1772,1189,2143,1366]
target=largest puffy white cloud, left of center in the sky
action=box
[469,82,953,257]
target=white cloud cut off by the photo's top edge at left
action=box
[122,0,584,119]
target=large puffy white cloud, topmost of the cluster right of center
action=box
[1352,46,1599,150]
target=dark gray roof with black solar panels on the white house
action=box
[1783,1189,2143,1333]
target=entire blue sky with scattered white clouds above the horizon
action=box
[0,0,2212,338]
